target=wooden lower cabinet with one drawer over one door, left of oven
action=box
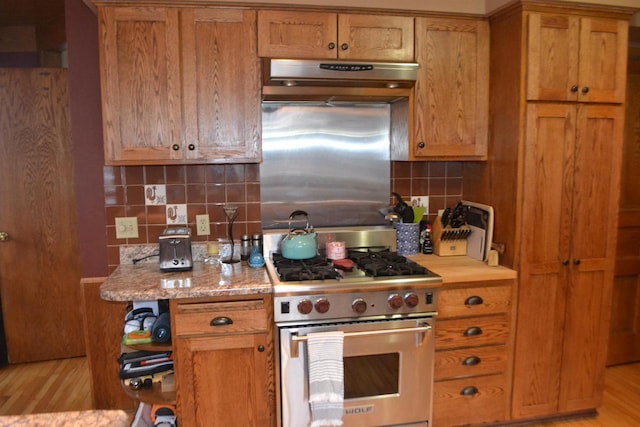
[171,296,275,427]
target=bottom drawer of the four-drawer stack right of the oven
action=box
[433,375,508,427]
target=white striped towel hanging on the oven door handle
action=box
[307,331,344,427]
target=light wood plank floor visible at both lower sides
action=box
[0,357,640,427]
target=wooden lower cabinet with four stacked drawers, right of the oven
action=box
[433,280,515,427]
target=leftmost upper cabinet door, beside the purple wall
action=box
[99,7,183,164]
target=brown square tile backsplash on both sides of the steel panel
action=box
[104,162,462,271]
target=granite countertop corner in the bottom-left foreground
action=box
[0,410,130,427]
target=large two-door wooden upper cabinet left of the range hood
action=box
[98,6,261,165]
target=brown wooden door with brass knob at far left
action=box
[0,68,84,363]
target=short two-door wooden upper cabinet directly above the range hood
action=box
[258,10,414,62]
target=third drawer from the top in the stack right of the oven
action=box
[434,345,508,381]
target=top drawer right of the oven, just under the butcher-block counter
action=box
[438,282,512,319]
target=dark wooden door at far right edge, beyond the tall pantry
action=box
[607,69,640,365]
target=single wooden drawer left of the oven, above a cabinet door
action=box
[172,300,267,336]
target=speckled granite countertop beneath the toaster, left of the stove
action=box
[100,261,272,301]
